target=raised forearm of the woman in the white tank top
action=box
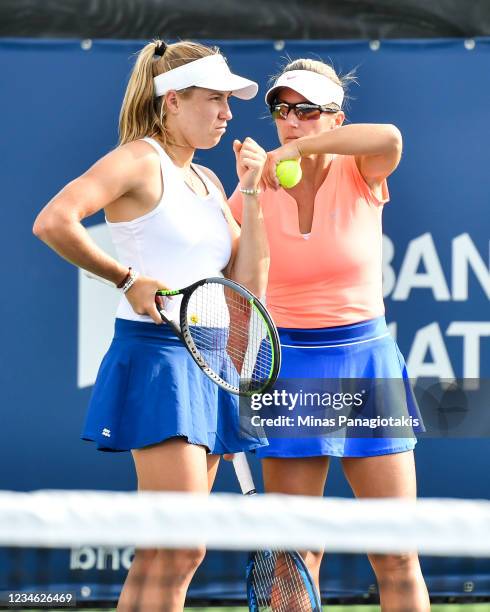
[230,194,269,297]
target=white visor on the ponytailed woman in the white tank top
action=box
[153,53,259,100]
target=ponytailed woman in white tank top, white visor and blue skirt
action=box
[34,41,269,612]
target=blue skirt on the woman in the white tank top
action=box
[82,319,267,454]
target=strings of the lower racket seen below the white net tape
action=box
[252,551,316,612]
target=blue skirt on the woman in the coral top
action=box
[256,317,424,457]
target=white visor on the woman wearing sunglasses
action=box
[265,70,344,107]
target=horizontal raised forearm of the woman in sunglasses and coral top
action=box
[295,123,402,156]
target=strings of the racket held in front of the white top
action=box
[186,283,274,390]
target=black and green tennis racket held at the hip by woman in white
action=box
[86,272,281,396]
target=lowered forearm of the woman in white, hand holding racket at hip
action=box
[33,211,128,284]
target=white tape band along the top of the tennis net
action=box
[0,491,490,557]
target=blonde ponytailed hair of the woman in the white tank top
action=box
[119,40,219,146]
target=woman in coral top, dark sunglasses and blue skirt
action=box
[230,59,429,612]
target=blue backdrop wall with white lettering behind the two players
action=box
[0,39,490,604]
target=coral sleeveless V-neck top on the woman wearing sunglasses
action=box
[228,155,389,329]
